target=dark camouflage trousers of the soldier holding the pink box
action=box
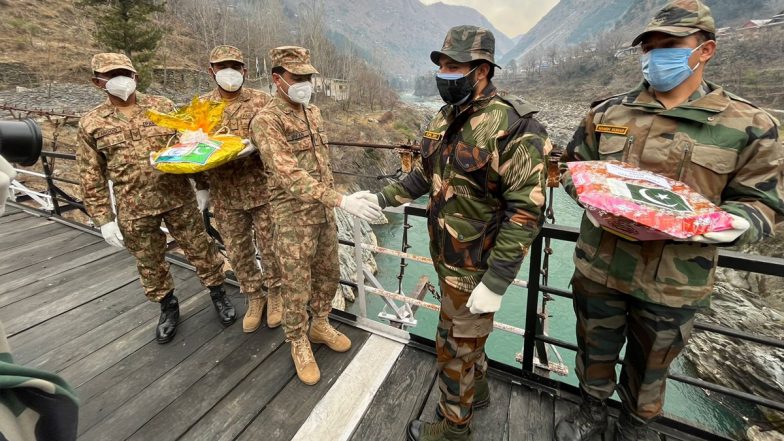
[572,271,697,421]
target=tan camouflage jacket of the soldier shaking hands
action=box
[251,97,342,225]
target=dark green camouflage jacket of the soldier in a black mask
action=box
[379,84,552,294]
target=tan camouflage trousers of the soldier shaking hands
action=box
[273,220,340,341]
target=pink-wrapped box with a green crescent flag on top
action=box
[567,161,732,240]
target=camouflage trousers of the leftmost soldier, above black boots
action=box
[119,203,224,302]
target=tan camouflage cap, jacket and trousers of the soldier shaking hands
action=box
[251,47,342,341]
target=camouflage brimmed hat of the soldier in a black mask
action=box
[430,25,501,69]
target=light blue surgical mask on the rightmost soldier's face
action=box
[640,43,704,92]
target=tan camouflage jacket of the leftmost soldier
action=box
[76,93,194,226]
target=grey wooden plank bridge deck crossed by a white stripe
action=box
[0,207,716,441]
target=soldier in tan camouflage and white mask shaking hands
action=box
[251,46,381,385]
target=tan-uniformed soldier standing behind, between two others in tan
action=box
[196,46,283,332]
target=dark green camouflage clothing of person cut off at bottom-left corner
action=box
[0,323,79,441]
